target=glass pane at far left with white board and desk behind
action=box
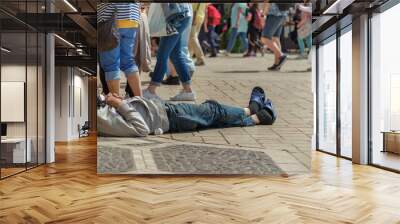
[0,32,27,177]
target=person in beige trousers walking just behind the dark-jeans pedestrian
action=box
[189,3,207,66]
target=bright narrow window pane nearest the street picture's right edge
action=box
[318,40,336,153]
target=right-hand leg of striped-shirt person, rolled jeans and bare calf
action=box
[120,28,142,96]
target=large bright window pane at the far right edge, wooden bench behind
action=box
[371,4,400,170]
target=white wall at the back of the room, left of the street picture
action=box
[55,67,88,141]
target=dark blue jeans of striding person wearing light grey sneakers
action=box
[151,17,191,86]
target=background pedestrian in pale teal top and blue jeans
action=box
[224,3,247,55]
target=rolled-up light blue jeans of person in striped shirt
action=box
[99,28,139,81]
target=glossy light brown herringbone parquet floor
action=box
[0,137,400,224]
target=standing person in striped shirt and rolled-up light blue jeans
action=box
[97,3,142,96]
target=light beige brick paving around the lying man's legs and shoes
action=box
[100,54,313,174]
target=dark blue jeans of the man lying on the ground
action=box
[166,101,255,132]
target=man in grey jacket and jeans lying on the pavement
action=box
[97,87,277,137]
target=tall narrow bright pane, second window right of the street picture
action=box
[340,31,353,158]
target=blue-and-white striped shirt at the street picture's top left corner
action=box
[97,3,140,22]
